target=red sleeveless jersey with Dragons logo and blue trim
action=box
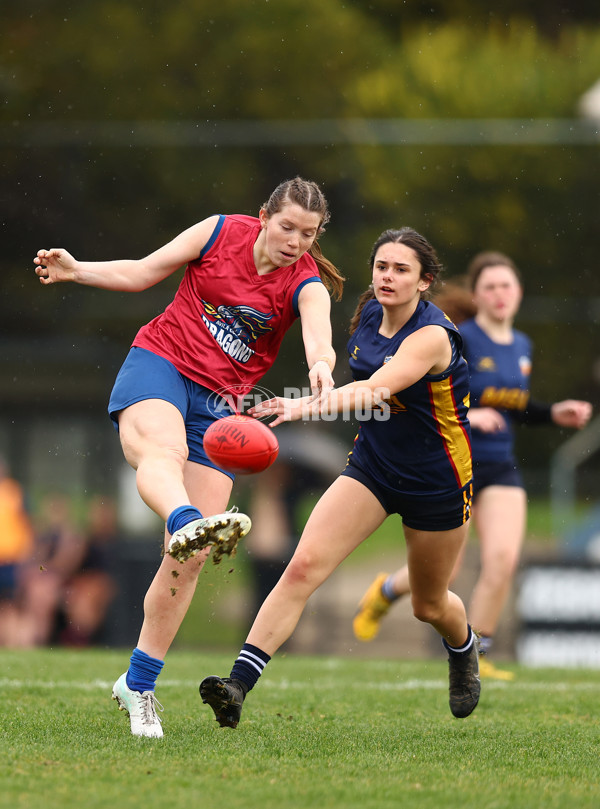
[133,215,321,396]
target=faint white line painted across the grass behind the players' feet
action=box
[0,677,600,692]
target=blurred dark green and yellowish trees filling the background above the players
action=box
[0,0,600,474]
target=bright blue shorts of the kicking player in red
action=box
[108,346,235,480]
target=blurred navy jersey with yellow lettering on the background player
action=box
[460,320,532,463]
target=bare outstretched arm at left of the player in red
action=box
[33,216,218,292]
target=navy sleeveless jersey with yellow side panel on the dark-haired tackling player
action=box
[348,300,472,497]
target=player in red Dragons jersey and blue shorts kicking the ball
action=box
[34,177,344,737]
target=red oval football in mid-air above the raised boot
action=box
[204,415,279,475]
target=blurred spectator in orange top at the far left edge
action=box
[0,458,33,646]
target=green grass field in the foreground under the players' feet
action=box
[0,649,600,809]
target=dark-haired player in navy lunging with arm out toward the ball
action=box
[200,228,480,727]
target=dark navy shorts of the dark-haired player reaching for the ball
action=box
[342,463,473,531]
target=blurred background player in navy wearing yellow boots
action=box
[353,251,592,680]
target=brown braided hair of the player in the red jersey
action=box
[262,177,346,301]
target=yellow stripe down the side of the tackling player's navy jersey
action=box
[428,377,473,488]
